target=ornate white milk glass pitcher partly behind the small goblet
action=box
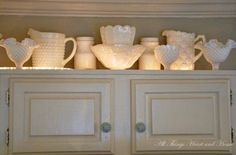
[162,30,206,70]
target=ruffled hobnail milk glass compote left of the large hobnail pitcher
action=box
[0,38,38,69]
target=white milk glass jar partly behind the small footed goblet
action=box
[139,37,161,70]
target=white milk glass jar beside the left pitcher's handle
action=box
[74,37,96,69]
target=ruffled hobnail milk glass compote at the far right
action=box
[201,39,236,70]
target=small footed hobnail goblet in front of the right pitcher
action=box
[154,45,179,70]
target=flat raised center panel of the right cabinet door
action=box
[151,94,217,135]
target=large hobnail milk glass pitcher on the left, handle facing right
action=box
[28,29,77,68]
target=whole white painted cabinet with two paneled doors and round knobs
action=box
[0,70,236,155]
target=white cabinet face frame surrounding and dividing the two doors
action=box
[0,70,236,155]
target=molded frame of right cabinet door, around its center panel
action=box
[131,79,232,154]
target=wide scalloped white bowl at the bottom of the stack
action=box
[91,44,145,70]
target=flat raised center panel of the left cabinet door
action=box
[30,98,95,136]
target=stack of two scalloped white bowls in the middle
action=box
[91,25,145,70]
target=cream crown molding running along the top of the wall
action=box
[0,0,236,18]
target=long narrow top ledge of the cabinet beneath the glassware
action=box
[0,68,236,76]
